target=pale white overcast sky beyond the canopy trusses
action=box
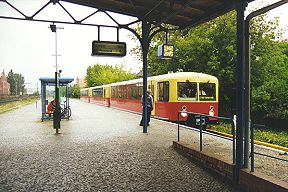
[0,0,288,89]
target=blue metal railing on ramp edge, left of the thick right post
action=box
[177,111,236,164]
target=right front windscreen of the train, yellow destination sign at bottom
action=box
[199,83,216,101]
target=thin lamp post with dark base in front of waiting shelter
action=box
[50,23,64,134]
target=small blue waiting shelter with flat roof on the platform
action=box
[39,77,74,121]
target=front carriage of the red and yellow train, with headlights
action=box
[152,72,218,124]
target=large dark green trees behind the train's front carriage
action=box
[132,11,288,122]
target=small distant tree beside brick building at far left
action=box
[7,69,25,95]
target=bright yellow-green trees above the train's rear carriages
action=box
[85,64,135,87]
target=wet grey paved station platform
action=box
[0,100,288,192]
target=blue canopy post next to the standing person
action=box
[142,20,149,133]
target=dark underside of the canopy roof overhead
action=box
[63,0,254,28]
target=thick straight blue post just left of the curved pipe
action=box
[234,1,247,182]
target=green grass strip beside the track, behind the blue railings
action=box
[209,122,288,148]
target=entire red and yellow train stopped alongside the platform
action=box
[81,72,219,126]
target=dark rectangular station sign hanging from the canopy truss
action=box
[91,41,127,57]
